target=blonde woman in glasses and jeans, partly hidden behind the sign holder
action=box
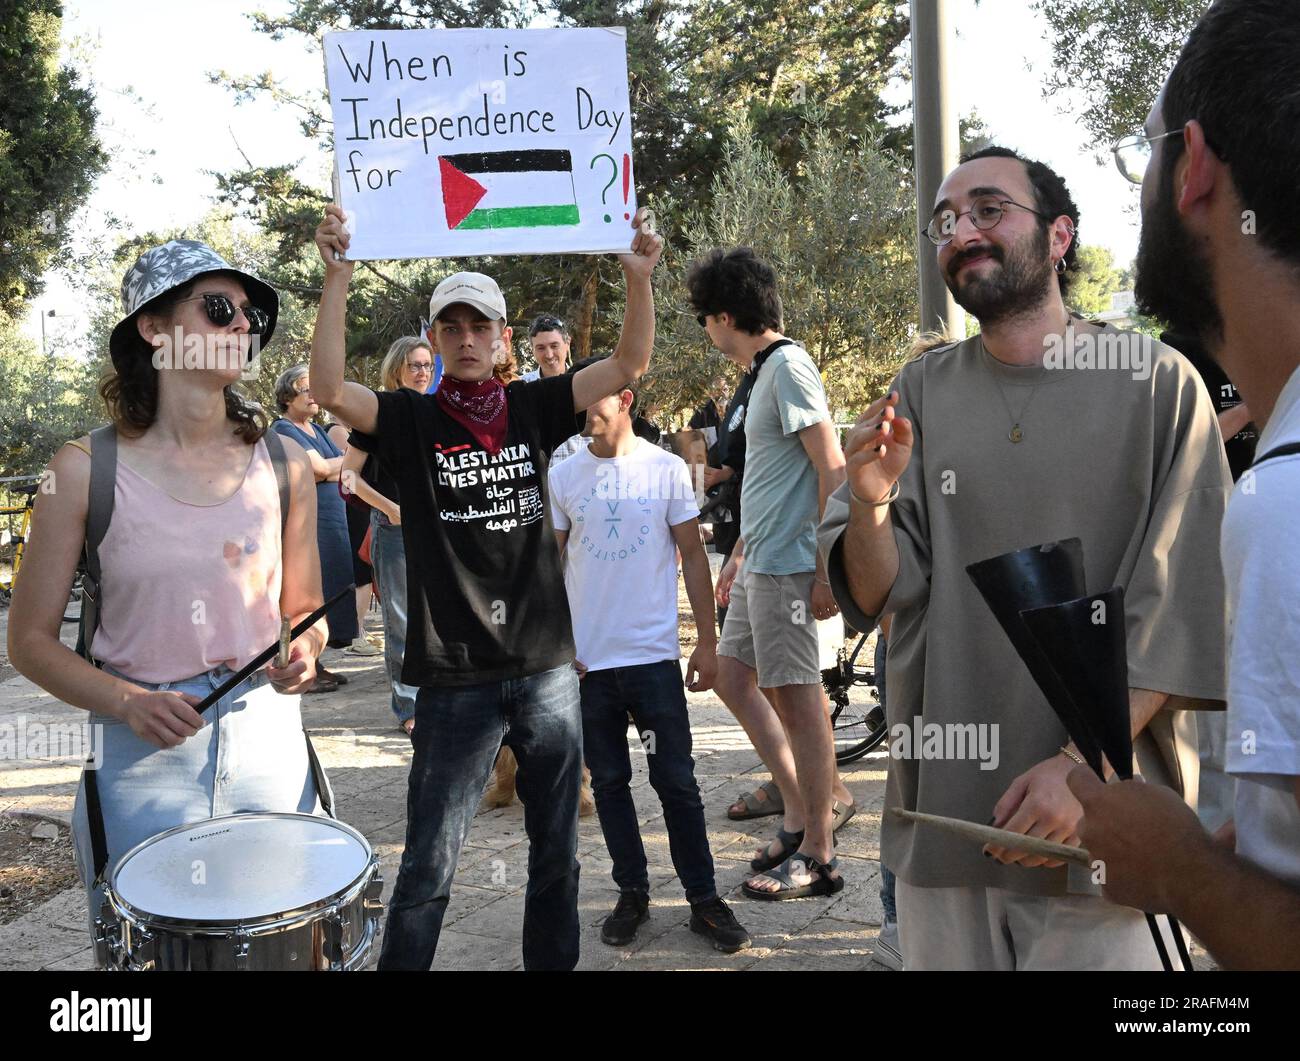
[341,335,433,733]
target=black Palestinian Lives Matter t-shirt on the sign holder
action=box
[361,374,575,685]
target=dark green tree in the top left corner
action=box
[0,0,107,317]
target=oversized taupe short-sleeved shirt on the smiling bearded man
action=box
[818,326,1231,895]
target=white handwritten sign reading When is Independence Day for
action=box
[325,29,637,259]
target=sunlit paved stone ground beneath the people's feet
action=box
[0,612,885,970]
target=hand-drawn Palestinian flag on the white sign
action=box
[438,150,579,230]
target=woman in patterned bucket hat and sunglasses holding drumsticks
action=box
[9,241,330,941]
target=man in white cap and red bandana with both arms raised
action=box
[311,205,663,970]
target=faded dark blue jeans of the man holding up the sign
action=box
[380,663,582,970]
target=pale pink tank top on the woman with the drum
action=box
[91,441,281,683]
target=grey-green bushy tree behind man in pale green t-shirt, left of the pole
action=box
[646,118,917,417]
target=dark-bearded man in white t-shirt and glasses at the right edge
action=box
[1069,0,1300,969]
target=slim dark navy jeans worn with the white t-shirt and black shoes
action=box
[580,659,718,902]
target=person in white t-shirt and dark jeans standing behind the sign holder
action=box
[550,358,750,953]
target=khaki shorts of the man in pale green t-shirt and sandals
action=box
[718,567,822,689]
